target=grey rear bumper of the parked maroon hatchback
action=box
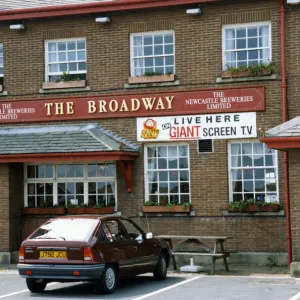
[18,264,105,281]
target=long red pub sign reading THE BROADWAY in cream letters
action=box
[0,86,265,123]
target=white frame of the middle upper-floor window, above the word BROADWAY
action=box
[130,30,176,77]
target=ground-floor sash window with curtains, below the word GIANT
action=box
[145,144,191,205]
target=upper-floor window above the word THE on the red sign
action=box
[45,39,86,82]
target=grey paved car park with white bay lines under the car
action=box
[0,265,300,300]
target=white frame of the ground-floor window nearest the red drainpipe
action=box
[227,139,279,202]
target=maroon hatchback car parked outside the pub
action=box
[18,215,170,294]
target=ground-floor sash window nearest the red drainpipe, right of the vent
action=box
[229,142,278,202]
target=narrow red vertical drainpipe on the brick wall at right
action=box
[280,0,292,265]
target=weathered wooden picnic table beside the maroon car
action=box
[155,235,233,275]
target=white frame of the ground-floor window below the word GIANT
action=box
[144,143,192,204]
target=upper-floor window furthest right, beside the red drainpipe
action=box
[223,22,272,70]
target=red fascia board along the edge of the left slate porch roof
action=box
[0,151,139,164]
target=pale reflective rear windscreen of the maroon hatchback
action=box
[29,218,99,241]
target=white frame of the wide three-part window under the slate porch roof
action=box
[24,162,118,210]
